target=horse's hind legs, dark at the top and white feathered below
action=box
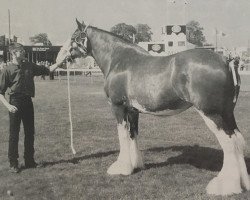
[198,111,250,195]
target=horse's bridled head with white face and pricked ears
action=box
[57,19,90,63]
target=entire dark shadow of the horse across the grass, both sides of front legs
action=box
[38,145,250,173]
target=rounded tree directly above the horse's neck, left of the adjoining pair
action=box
[110,23,136,42]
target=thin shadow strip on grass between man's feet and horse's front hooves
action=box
[41,151,118,167]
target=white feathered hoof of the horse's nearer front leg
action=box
[107,161,134,175]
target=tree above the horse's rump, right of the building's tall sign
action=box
[187,20,206,46]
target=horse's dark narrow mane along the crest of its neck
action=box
[91,26,150,55]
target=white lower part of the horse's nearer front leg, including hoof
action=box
[107,121,133,175]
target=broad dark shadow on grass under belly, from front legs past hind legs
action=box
[145,145,250,173]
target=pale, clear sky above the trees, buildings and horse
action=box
[0,0,250,48]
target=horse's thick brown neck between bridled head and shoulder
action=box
[88,27,146,77]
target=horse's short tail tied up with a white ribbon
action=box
[227,59,241,103]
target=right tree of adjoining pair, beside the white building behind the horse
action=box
[135,24,153,43]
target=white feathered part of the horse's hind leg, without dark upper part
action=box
[198,111,245,195]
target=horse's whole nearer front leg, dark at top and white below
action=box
[107,105,134,175]
